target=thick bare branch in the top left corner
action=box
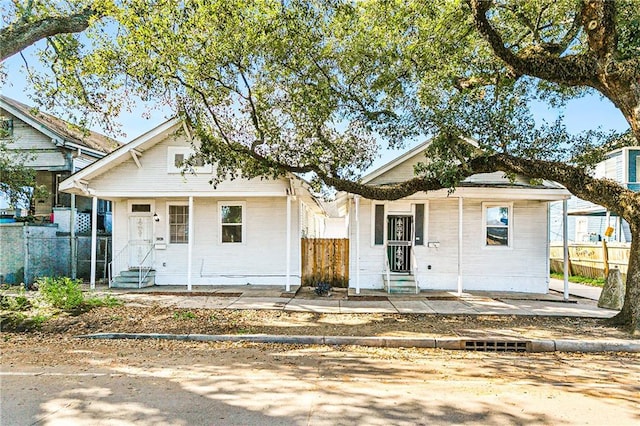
[0,6,102,61]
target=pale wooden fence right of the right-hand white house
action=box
[550,242,630,280]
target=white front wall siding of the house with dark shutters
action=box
[350,198,548,293]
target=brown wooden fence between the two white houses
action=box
[301,238,349,287]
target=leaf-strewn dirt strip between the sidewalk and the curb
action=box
[3,305,638,340]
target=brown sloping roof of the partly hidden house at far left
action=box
[0,95,121,154]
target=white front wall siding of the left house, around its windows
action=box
[113,197,300,285]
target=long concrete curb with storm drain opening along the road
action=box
[76,333,640,353]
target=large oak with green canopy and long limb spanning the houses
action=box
[3,0,640,331]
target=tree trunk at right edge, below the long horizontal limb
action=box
[611,218,640,334]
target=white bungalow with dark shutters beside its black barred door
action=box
[346,142,570,293]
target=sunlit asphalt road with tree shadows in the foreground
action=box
[0,339,640,425]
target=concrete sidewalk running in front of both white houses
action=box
[111,286,617,318]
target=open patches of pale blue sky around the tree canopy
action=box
[0,42,629,174]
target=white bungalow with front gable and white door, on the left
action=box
[60,119,324,290]
